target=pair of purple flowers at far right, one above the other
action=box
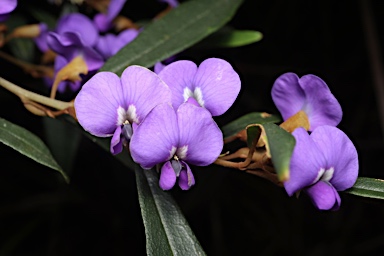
[272,73,359,210]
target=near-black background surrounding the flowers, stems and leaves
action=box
[0,0,384,255]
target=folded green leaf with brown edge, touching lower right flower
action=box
[263,123,296,181]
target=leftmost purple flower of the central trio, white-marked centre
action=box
[75,66,171,154]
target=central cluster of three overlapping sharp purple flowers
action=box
[75,58,241,190]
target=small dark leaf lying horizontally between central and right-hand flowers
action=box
[221,112,281,138]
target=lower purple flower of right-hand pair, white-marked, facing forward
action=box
[284,125,359,210]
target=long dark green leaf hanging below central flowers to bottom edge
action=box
[135,166,205,256]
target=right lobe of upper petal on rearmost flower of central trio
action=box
[193,58,241,116]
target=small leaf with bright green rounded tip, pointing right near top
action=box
[196,27,263,49]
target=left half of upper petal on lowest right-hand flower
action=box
[284,127,326,196]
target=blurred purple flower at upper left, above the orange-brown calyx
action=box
[47,13,104,72]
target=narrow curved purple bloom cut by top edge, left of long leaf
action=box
[93,0,126,32]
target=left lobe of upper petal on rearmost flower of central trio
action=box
[159,60,197,109]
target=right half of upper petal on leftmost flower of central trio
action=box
[121,65,171,123]
